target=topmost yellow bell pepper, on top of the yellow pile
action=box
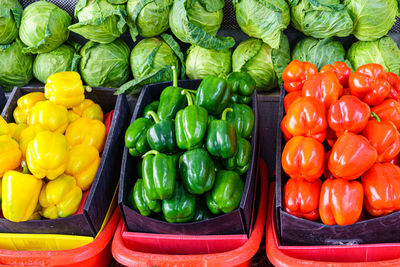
[44,71,85,108]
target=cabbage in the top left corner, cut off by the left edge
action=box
[0,0,22,45]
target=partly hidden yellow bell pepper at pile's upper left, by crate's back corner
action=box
[13,92,45,123]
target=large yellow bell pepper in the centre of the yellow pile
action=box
[26,131,68,180]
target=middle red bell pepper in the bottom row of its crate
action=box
[319,178,364,226]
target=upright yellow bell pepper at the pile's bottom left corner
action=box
[1,171,43,222]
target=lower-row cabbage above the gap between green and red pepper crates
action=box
[232,34,290,91]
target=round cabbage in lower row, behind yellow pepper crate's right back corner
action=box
[79,39,130,88]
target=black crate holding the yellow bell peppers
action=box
[0,87,130,236]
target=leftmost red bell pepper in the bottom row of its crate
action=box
[283,179,322,221]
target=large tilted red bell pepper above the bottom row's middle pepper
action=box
[328,132,378,180]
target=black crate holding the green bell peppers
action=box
[118,80,258,235]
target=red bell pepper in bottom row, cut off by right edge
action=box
[361,163,400,216]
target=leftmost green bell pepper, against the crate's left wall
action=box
[125,118,153,157]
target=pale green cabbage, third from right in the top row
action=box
[233,0,290,48]
